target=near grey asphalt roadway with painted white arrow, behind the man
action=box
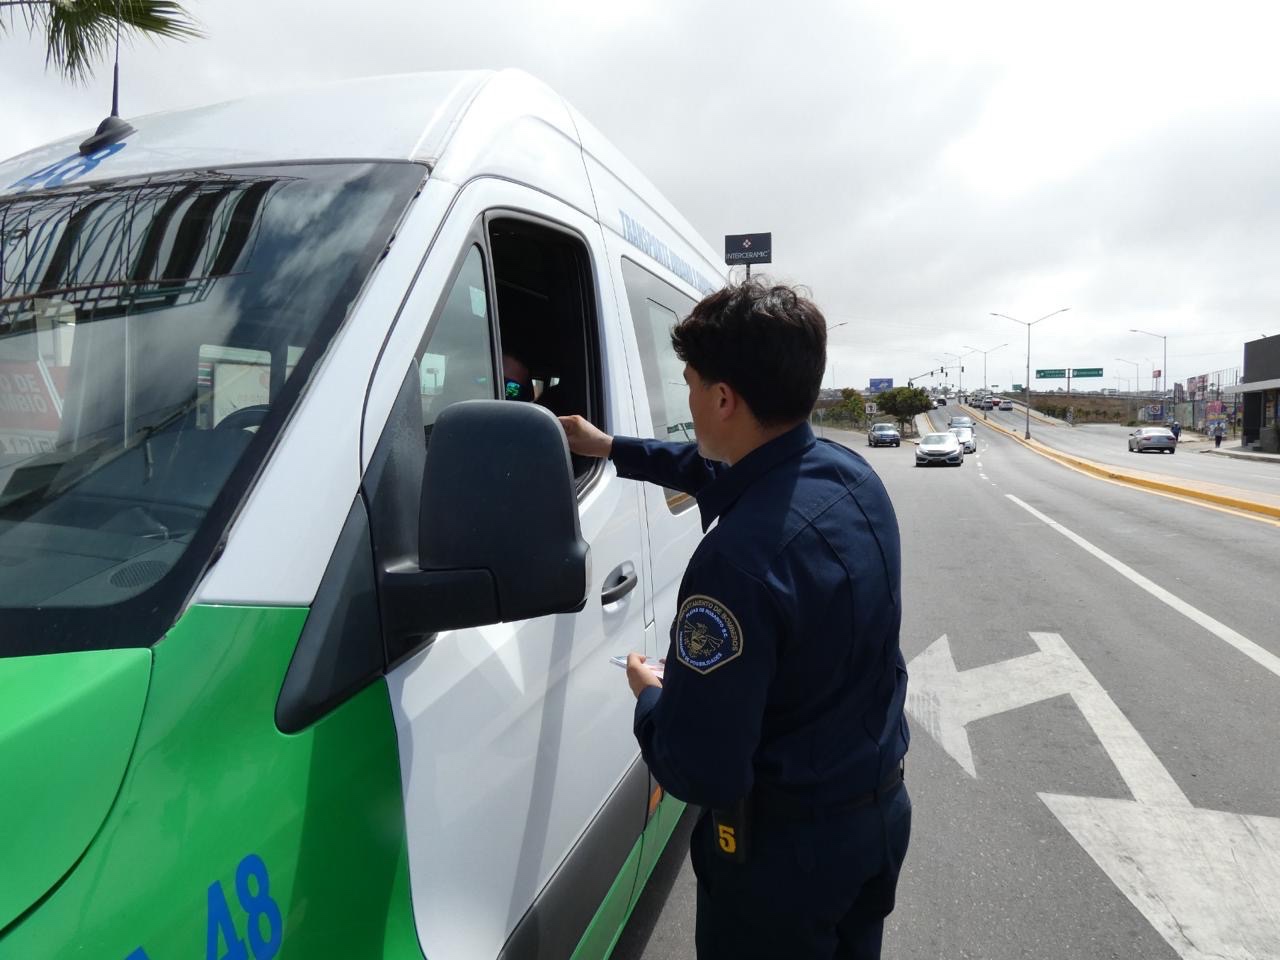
[614,411,1280,960]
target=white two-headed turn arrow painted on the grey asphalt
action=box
[906,634,1280,960]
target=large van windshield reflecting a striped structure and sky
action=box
[0,163,425,657]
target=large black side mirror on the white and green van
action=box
[381,401,591,647]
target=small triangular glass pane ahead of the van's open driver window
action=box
[417,244,498,429]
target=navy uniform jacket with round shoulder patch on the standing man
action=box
[611,424,908,808]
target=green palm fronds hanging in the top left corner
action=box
[0,0,200,83]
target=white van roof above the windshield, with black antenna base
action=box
[0,69,723,292]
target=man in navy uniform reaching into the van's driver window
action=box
[562,280,911,960]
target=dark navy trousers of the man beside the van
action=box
[690,785,911,960]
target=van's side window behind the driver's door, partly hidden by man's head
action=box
[622,257,695,509]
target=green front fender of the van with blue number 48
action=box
[0,607,422,960]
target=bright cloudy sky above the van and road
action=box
[0,0,1280,389]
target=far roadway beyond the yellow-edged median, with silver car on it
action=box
[967,410,1280,497]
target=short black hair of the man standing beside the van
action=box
[671,279,827,426]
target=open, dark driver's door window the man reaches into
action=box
[489,221,603,488]
